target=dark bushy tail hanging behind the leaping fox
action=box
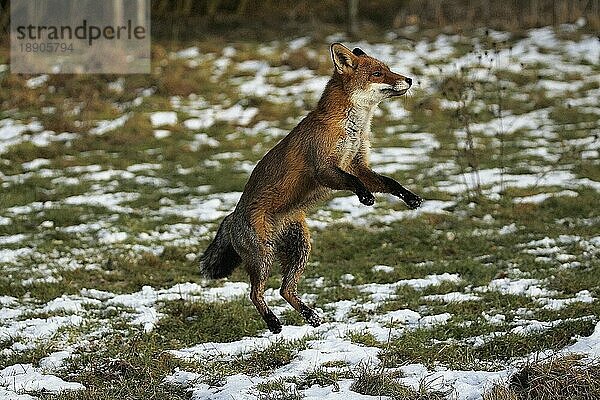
[200,214,242,279]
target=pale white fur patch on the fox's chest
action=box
[336,107,373,167]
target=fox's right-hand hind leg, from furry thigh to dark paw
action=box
[276,221,321,327]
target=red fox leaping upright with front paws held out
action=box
[200,43,423,333]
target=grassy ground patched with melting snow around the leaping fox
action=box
[0,25,600,399]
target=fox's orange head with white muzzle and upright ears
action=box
[331,43,412,107]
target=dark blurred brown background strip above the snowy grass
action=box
[0,0,600,41]
